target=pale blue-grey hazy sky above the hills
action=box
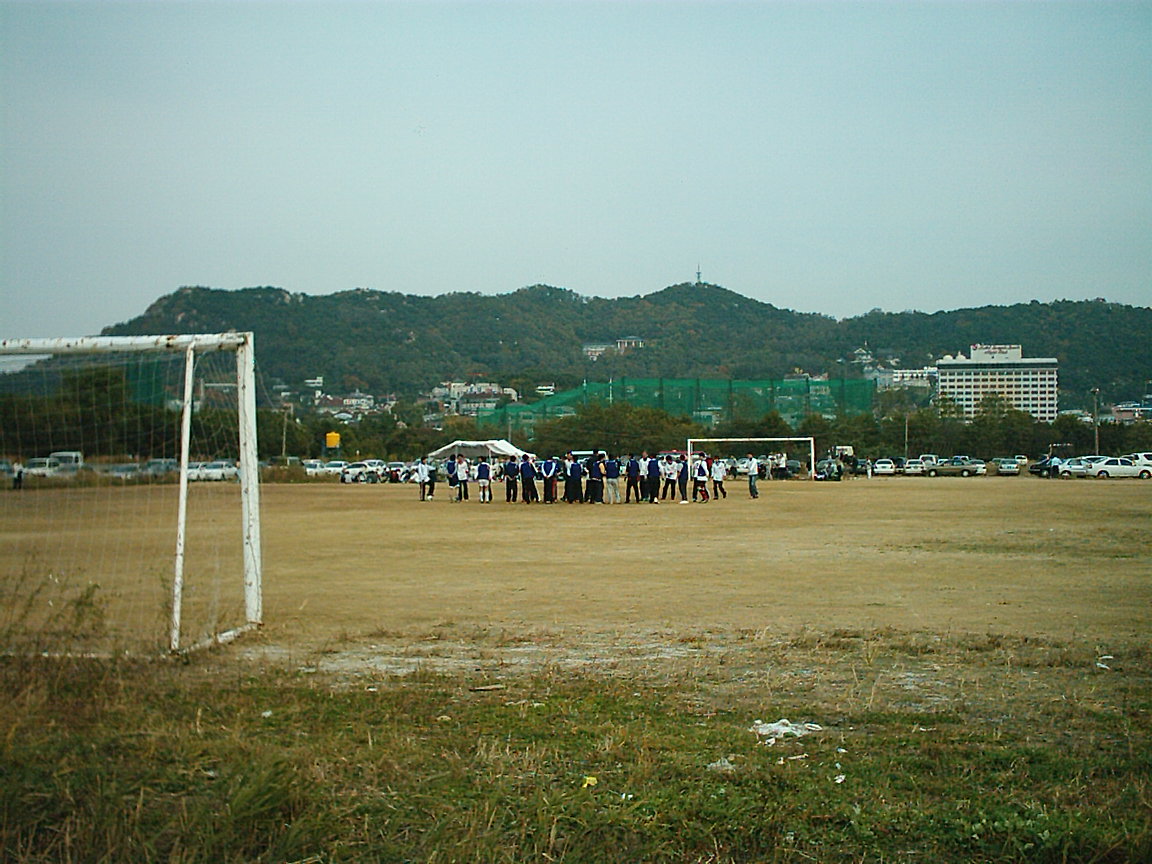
[0,0,1152,338]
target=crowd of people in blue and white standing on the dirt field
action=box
[405,450,764,505]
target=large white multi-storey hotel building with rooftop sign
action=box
[937,344,1059,423]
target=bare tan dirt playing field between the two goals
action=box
[0,477,1152,653]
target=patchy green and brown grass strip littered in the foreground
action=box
[0,632,1152,863]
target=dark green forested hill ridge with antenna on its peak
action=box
[104,283,1152,404]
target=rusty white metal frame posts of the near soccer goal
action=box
[0,332,264,652]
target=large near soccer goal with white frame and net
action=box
[0,333,263,654]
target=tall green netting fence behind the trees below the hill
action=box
[477,378,876,434]
